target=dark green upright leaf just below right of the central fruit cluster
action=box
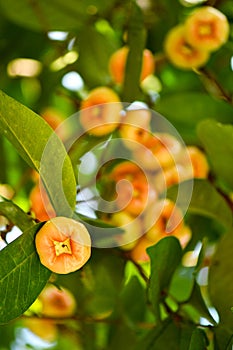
[147,236,182,320]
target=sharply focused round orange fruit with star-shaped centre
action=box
[35,217,91,274]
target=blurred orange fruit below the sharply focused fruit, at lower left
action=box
[38,285,76,318]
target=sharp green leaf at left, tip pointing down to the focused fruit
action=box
[0,91,76,216]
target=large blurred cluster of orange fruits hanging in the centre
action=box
[94,104,209,262]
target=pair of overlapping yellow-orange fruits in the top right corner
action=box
[164,6,230,69]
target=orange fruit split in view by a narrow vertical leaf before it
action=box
[109,46,155,84]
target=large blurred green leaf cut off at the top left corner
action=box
[0,0,116,32]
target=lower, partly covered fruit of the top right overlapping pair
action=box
[164,25,209,70]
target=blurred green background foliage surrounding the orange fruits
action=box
[0,0,233,350]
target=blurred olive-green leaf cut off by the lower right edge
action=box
[208,231,233,330]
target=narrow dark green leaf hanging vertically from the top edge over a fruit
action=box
[123,1,146,102]
